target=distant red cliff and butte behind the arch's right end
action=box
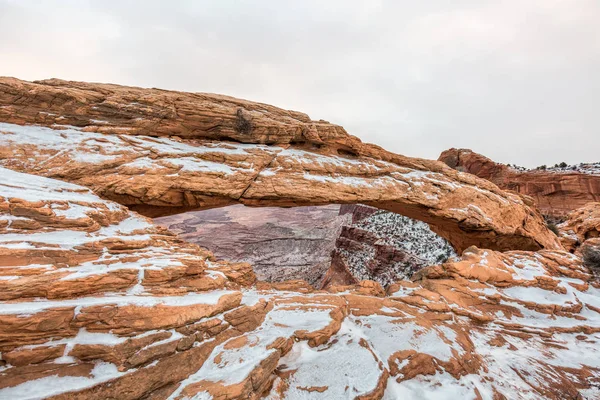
[439,149,600,217]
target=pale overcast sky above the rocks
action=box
[0,0,600,167]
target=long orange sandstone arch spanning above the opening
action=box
[0,78,561,251]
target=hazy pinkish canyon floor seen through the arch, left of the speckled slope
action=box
[155,205,350,286]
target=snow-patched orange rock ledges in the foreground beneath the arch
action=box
[0,168,600,400]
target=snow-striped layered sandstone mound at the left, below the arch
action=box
[0,168,253,399]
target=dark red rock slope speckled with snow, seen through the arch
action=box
[322,205,456,287]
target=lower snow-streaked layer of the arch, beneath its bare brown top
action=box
[0,117,557,253]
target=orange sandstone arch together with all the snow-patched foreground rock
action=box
[0,79,600,400]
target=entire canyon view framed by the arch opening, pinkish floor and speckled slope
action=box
[155,205,456,288]
